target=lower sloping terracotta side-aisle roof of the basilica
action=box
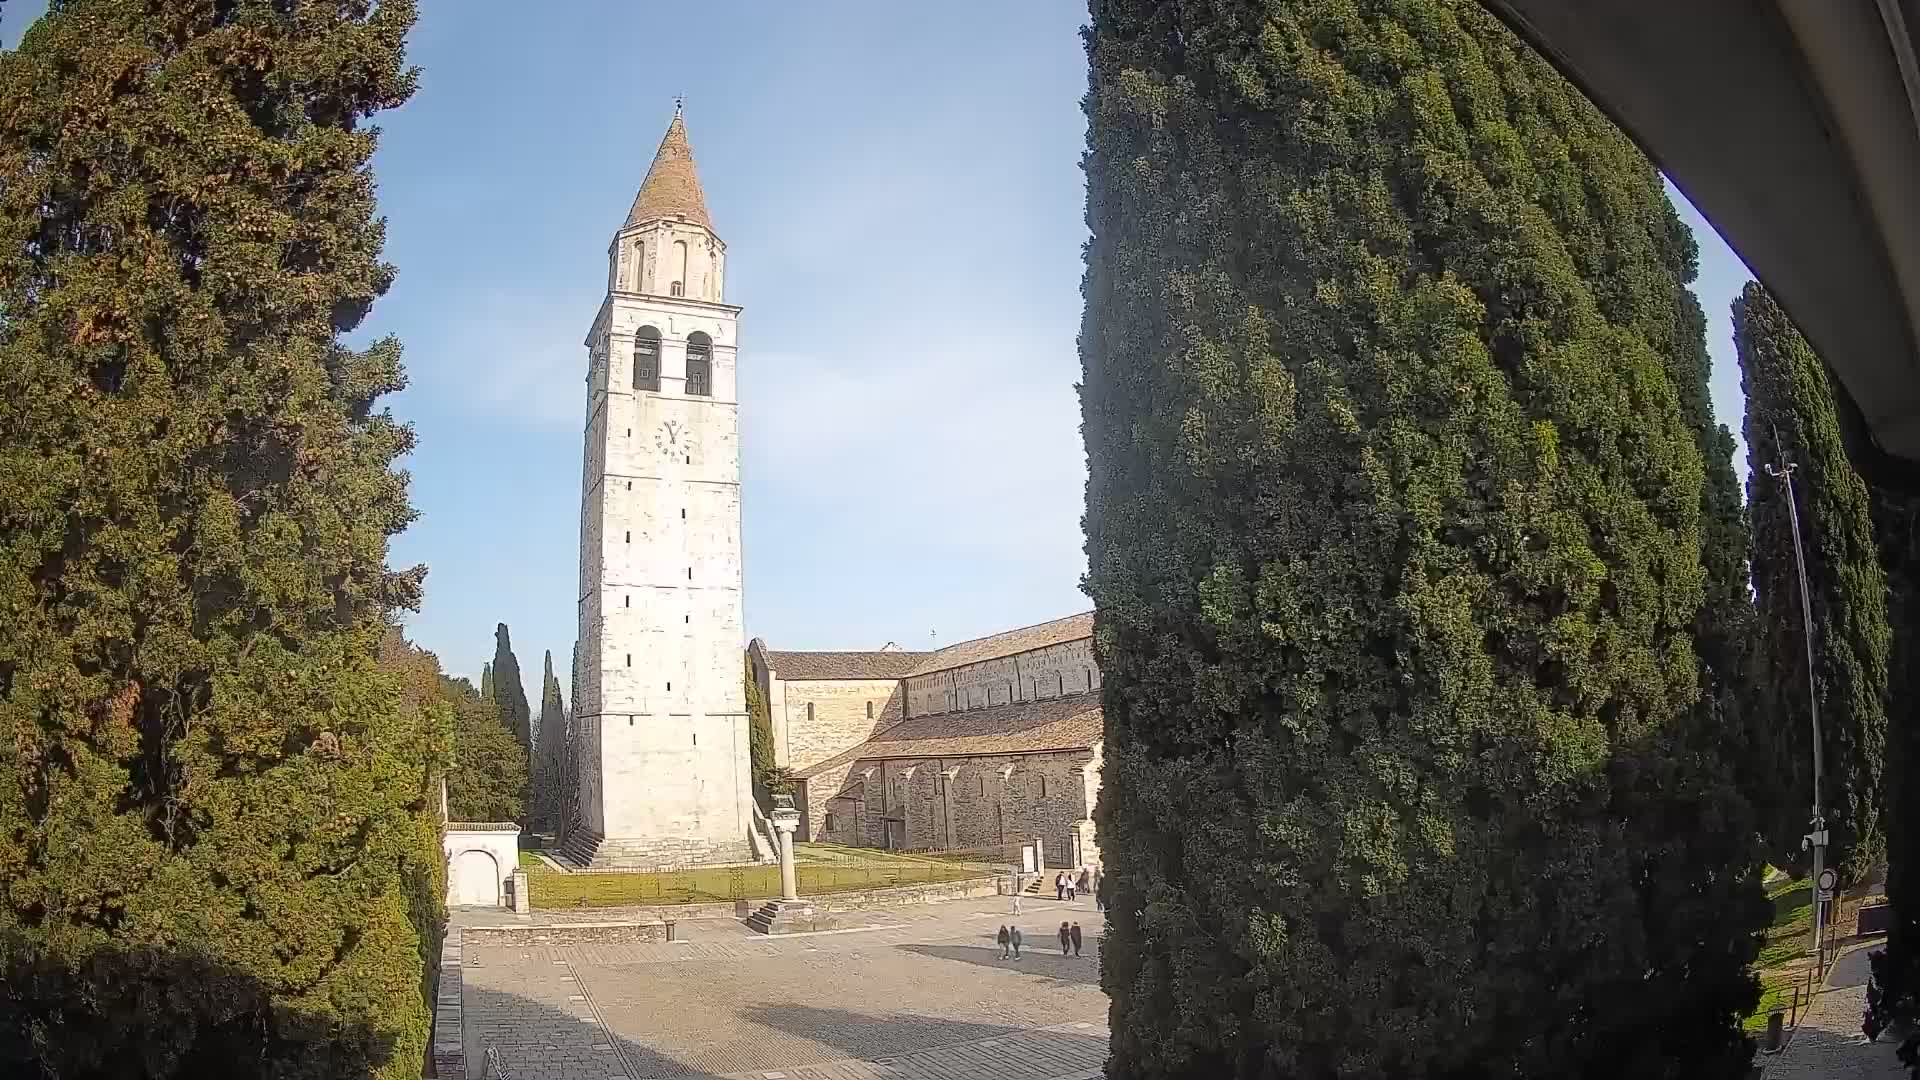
[797,694,1102,778]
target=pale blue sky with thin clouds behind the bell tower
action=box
[4,0,1747,696]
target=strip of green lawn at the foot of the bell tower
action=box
[520,844,989,909]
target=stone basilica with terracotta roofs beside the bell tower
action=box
[749,613,1100,867]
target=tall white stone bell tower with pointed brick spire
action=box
[564,110,756,869]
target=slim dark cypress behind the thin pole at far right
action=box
[1734,282,1891,882]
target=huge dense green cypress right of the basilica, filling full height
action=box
[1081,0,1763,1078]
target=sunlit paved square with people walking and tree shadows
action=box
[465,899,1106,1080]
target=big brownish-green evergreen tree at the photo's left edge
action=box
[0,0,434,1078]
